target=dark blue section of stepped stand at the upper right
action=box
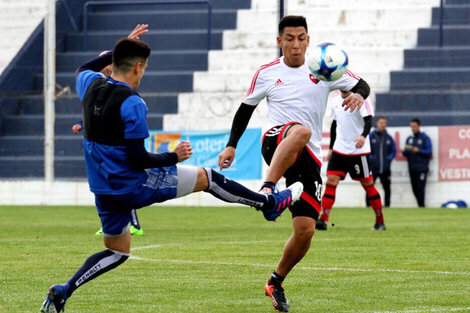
[377,0,470,126]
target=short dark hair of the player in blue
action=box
[113,38,152,73]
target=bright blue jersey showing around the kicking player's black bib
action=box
[76,70,149,195]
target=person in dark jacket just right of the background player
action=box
[366,116,396,207]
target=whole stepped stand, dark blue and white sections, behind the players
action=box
[0,0,464,178]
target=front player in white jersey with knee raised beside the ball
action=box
[219,16,369,312]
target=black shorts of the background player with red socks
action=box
[326,150,373,181]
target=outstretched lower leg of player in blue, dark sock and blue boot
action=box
[205,169,303,221]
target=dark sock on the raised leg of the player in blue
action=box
[205,168,274,209]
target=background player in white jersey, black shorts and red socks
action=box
[316,92,386,230]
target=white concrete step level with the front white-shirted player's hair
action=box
[237,5,431,29]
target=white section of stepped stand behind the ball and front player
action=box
[163,0,439,130]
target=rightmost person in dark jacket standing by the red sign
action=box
[403,119,432,207]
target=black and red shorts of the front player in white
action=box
[261,122,322,220]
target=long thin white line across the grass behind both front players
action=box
[130,255,470,276]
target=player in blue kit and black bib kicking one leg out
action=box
[40,25,303,313]
